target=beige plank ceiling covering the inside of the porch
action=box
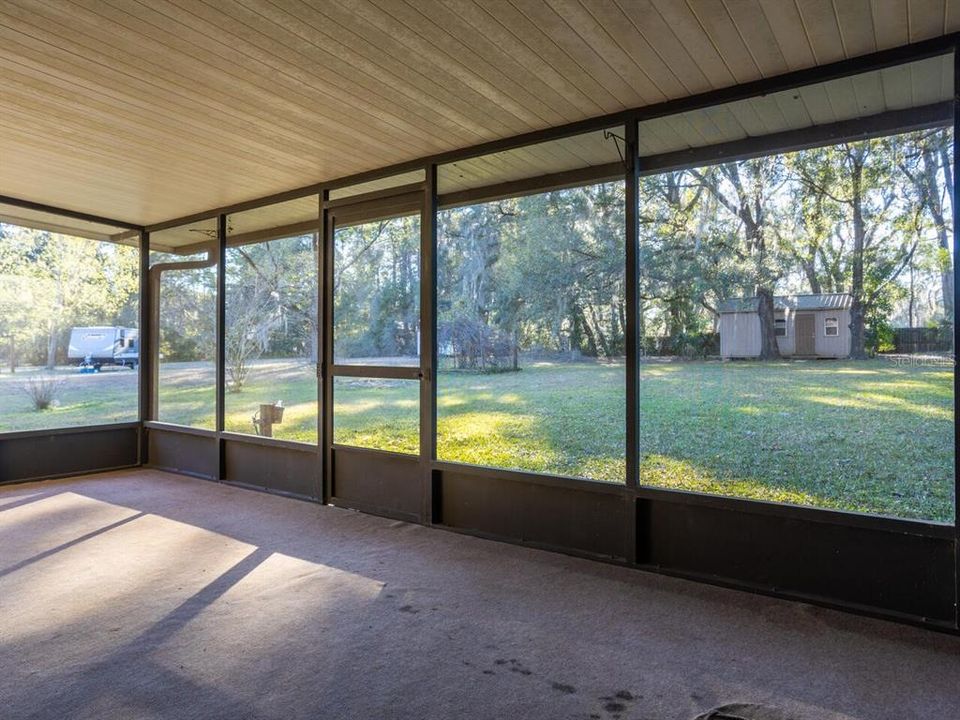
[0,0,960,224]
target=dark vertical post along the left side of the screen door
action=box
[316,190,333,504]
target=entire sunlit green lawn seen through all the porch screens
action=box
[0,359,954,522]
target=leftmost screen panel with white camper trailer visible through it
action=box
[0,217,140,432]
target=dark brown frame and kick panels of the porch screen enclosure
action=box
[0,34,960,631]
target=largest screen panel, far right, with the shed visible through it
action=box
[637,55,956,523]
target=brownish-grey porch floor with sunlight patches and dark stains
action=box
[0,470,960,720]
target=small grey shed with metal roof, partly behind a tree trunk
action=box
[719,293,853,358]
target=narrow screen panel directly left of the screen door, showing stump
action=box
[224,195,320,443]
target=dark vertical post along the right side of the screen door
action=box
[420,163,437,525]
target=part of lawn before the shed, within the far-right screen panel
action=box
[640,359,954,521]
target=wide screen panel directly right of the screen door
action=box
[437,174,626,483]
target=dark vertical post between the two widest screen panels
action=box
[623,117,640,563]
